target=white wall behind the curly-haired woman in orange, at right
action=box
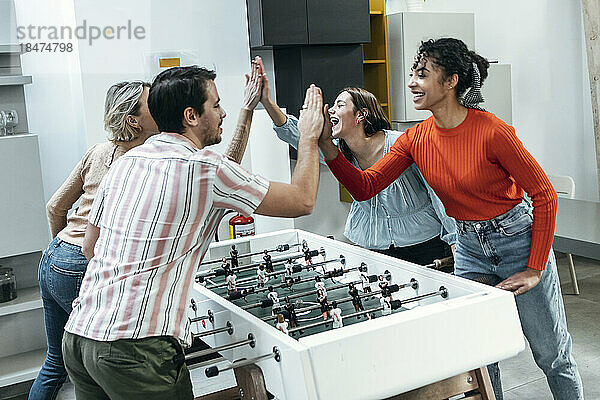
[387,0,598,200]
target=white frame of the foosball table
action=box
[190,229,524,400]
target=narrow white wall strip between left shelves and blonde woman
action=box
[15,0,87,201]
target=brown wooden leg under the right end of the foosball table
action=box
[386,367,496,400]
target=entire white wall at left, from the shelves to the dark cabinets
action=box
[21,0,292,237]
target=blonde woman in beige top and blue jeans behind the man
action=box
[29,81,158,399]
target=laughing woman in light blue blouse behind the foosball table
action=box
[261,62,456,265]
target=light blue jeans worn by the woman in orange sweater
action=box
[454,202,583,400]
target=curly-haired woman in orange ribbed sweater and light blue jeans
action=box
[319,38,583,399]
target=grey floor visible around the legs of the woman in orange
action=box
[16,255,600,400]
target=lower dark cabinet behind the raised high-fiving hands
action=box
[273,44,363,116]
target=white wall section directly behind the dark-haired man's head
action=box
[75,0,250,150]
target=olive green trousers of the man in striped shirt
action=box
[62,332,194,400]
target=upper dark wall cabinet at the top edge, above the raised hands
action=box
[247,0,371,48]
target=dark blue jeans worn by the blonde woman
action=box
[29,237,88,400]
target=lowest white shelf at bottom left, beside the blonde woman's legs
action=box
[0,348,46,387]
